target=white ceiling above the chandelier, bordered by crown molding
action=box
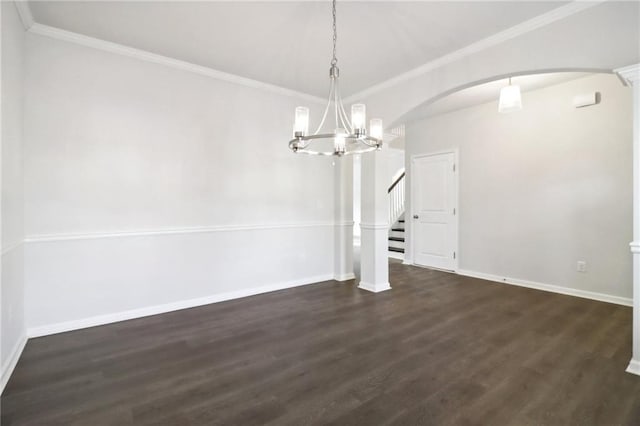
[29,1,566,97]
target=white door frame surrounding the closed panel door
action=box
[405,147,460,273]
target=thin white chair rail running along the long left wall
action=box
[24,222,335,243]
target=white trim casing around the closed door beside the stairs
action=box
[405,147,460,272]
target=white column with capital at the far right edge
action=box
[615,64,640,375]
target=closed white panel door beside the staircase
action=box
[410,152,458,271]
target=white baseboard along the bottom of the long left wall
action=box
[27,274,334,338]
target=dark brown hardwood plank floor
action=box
[2,262,640,426]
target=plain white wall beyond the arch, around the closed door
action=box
[406,74,633,298]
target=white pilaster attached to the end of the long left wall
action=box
[333,156,355,281]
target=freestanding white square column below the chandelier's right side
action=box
[358,152,391,293]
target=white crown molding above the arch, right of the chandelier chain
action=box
[344,0,606,104]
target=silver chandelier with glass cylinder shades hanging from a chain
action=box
[289,0,383,156]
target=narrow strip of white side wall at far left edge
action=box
[0,2,26,391]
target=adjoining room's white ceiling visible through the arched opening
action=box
[403,72,592,122]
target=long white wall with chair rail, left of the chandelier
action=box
[25,34,334,334]
